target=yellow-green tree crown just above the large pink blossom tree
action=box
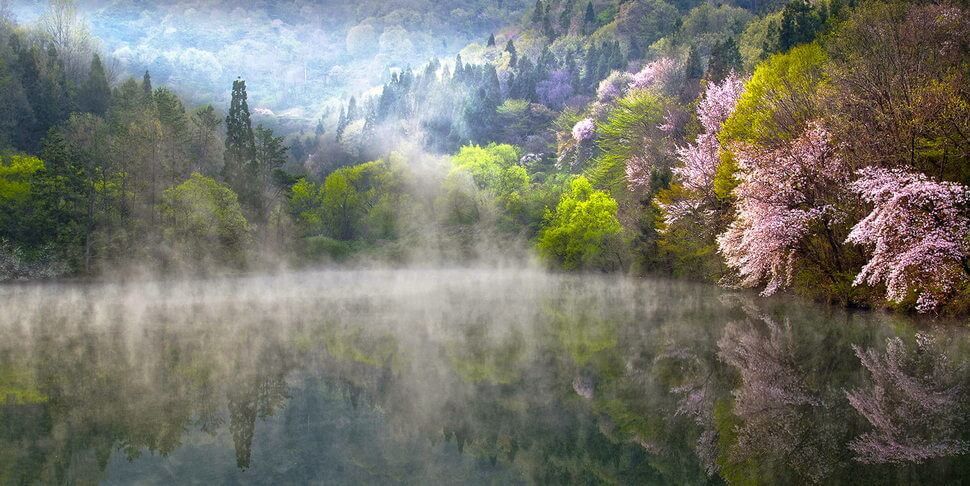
[718,44,828,146]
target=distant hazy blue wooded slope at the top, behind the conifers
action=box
[7,0,528,119]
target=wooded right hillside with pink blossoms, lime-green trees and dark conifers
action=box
[292,0,970,313]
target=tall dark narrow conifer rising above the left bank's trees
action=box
[222,79,258,208]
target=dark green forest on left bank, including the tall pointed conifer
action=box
[0,8,294,278]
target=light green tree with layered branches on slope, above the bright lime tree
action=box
[585,90,664,194]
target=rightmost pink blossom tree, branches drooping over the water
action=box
[847,167,970,312]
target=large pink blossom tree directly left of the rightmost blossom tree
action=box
[717,123,848,295]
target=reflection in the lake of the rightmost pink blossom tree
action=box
[846,334,970,464]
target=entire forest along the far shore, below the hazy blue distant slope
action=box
[0,0,970,315]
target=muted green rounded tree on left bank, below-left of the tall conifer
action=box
[161,173,250,265]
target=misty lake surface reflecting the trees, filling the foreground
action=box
[0,269,970,484]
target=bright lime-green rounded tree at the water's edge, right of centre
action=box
[536,176,621,270]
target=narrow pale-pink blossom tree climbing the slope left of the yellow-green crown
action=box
[664,74,744,230]
